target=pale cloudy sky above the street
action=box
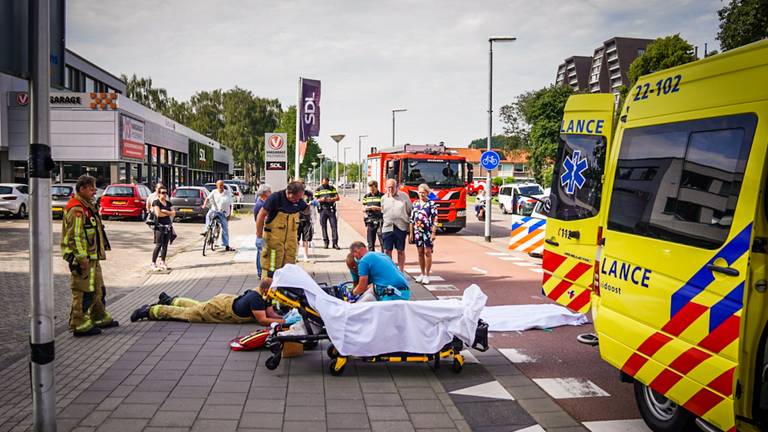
[67,0,723,160]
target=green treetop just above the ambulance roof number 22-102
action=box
[627,34,696,90]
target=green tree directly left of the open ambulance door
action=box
[501,85,574,184]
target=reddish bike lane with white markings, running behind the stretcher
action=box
[338,198,640,422]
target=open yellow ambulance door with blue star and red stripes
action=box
[542,94,614,313]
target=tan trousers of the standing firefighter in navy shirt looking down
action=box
[261,212,299,278]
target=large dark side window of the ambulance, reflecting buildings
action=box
[608,115,757,249]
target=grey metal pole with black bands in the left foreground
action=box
[29,0,56,432]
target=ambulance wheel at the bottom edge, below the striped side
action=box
[634,381,698,432]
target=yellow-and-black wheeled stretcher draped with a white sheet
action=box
[265,266,488,376]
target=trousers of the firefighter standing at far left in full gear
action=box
[69,260,112,333]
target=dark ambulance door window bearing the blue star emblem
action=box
[552,134,606,221]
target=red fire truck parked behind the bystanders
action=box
[368,144,472,232]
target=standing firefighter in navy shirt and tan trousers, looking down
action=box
[256,181,307,279]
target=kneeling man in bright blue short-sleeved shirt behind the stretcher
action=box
[349,241,411,301]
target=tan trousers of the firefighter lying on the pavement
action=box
[149,294,256,324]
